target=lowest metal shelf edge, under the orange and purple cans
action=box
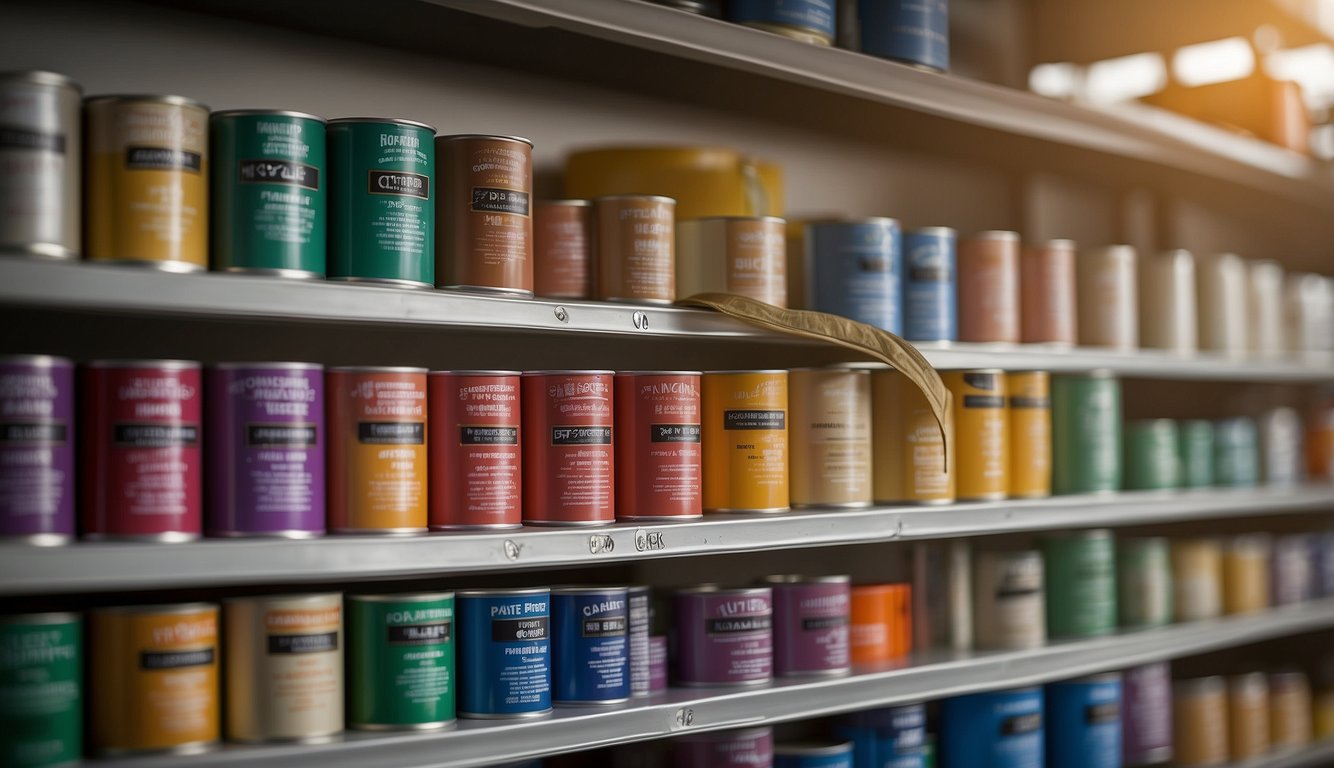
[104,600,1334,768]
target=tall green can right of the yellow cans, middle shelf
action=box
[1051,371,1121,493]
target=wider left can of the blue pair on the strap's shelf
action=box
[806,219,903,333]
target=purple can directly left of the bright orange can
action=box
[764,576,852,676]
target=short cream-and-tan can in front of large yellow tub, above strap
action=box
[676,216,787,307]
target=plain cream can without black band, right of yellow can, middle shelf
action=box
[787,368,871,508]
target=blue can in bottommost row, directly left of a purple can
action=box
[1045,675,1121,768]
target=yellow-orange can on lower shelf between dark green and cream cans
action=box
[88,603,218,757]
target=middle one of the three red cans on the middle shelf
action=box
[523,371,615,525]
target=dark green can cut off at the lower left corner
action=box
[0,613,83,768]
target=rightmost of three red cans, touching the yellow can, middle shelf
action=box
[616,371,704,520]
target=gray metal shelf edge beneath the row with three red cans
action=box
[0,485,1334,595]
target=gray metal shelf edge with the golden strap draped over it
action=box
[0,257,1334,383]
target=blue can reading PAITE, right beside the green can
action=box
[455,588,551,719]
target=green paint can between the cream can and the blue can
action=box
[346,592,456,731]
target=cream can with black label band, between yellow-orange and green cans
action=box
[223,592,343,741]
